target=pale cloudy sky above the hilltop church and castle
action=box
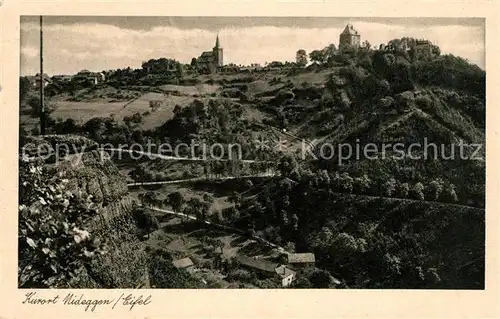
[21,16,485,75]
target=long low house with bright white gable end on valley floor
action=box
[236,255,296,287]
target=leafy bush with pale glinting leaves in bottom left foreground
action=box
[18,160,104,288]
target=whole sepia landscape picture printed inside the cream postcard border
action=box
[0,0,498,317]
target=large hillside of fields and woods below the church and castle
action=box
[21,40,485,289]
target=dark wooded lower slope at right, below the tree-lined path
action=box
[228,176,485,289]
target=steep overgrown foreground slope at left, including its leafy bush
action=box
[19,136,201,288]
